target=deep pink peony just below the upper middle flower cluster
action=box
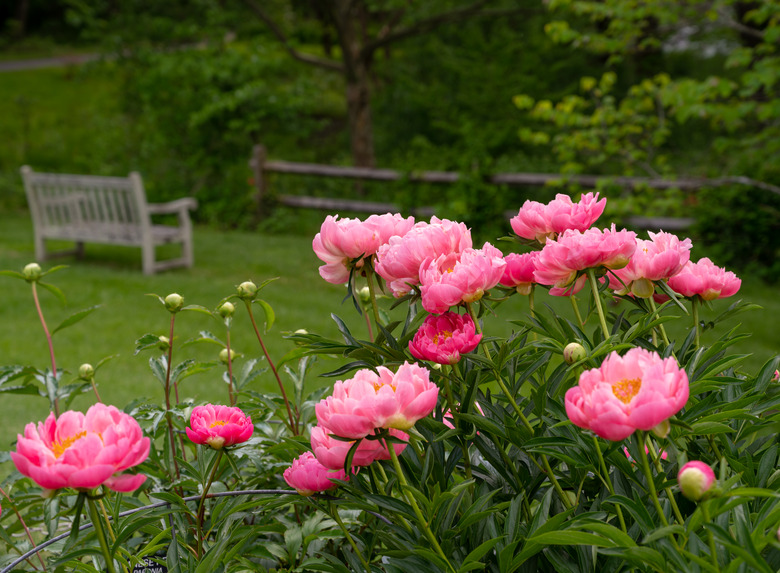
[409,312,482,364]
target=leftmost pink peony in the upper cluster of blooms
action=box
[312,213,414,284]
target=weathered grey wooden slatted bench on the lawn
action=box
[21,165,198,275]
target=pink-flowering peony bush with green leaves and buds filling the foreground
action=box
[0,193,780,573]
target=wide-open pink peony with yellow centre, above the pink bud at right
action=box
[565,348,688,441]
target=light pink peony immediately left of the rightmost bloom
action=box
[609,231,691,298]
